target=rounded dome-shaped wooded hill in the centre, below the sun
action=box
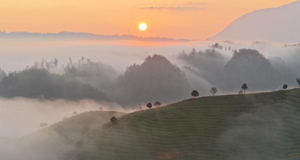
[114,55,190,104]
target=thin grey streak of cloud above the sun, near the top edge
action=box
[140,2,206,12]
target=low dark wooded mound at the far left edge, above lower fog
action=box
[0,68,108,100]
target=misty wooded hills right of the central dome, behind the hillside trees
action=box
[178,49,293,94]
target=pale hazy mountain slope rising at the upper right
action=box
[209,1,300,43]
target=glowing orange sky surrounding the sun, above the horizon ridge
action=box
[0,0,295,40]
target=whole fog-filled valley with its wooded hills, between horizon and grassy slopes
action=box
[0,38,300,159]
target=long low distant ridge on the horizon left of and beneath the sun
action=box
[0,31,190,42]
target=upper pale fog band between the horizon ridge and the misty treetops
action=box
[0,39,298,72]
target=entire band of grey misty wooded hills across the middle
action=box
[0,49,300,108]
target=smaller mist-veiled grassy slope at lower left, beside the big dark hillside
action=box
[5,111,125,160]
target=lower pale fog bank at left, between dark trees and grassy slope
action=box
[0,98,123,140]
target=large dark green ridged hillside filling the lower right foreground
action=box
[66,89,300,160]
